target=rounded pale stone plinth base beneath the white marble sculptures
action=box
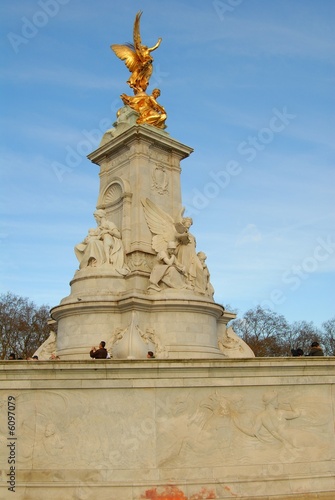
[51,290,244,360]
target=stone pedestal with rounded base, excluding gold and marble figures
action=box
[51,107,253,360]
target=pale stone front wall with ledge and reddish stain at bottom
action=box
[0,357,335,500]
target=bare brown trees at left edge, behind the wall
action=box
[0,292,50,359]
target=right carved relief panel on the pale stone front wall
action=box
[157,389,334,467]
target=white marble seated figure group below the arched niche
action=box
[74,209,128,275]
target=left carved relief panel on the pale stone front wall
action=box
[7,390,154,468]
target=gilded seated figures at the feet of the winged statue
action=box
[121,89,167,129]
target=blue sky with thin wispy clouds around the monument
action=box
[0,0,335,326]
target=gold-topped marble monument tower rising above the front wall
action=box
[51,12,253,360]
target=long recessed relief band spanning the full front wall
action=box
[0,384,335,470]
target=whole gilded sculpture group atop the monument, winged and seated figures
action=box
[111,11,167,129]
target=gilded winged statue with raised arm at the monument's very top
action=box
[111,11,162,95]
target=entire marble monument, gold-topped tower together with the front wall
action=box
[0,13,335,500]
